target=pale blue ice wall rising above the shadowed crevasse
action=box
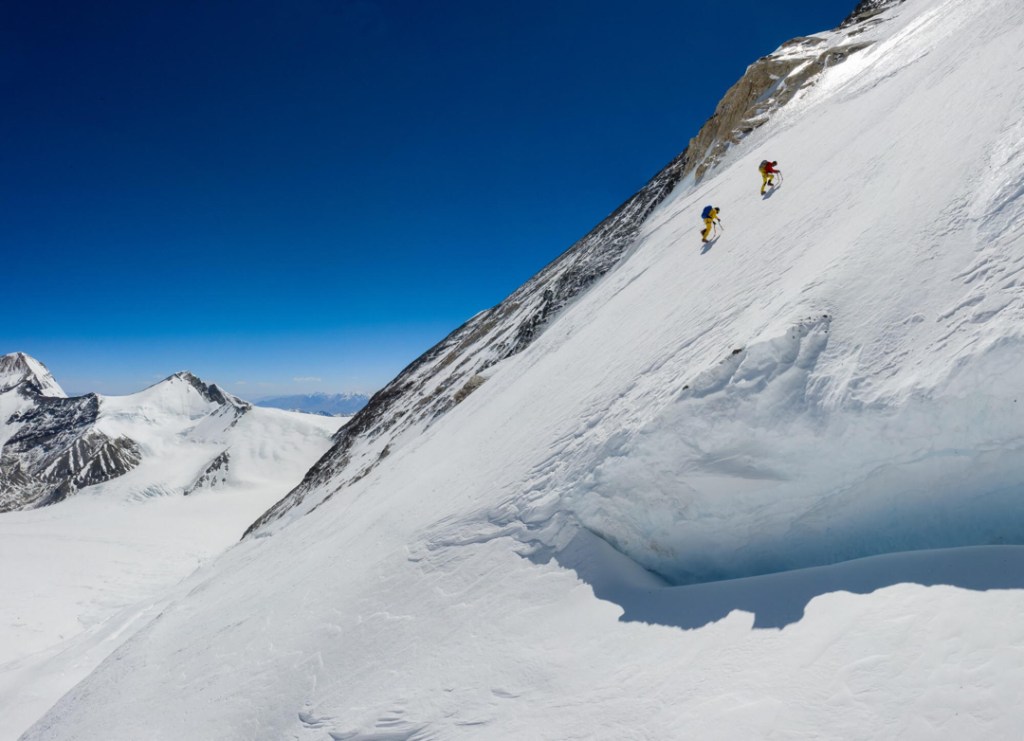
[560,337,1024,583]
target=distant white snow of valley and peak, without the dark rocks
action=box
[0,376,344,739]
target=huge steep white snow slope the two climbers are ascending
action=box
[16,0,1024,741]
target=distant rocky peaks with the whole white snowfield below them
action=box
[0,353,344,741]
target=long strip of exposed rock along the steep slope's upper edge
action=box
[247,0,898,535]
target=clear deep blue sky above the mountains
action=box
[0,0,856,398]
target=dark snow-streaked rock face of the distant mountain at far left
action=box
[0,390,141,512]
